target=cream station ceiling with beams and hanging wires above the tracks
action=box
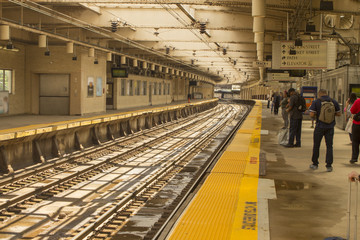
[1,0,360,84]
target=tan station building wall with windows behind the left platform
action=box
[0,44,214,117]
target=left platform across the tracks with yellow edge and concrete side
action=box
[0,98,218,174]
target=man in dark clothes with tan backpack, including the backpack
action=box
[309,89,341,172]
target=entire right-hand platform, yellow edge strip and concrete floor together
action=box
[168,102,360,240]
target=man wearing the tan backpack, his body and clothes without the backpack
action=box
[309,89,341,172]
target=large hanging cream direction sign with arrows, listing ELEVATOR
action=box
[272,40,336,69]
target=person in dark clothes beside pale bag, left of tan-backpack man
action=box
[284,88,302,147]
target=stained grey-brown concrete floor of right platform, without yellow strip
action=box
[261,104,360,240]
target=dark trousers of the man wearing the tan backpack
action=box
[312,127,334,167]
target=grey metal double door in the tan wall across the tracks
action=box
[39,74,70,115]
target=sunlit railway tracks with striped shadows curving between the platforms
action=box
[0,105,250,239]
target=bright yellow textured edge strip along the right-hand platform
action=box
[168,101,262,240]
